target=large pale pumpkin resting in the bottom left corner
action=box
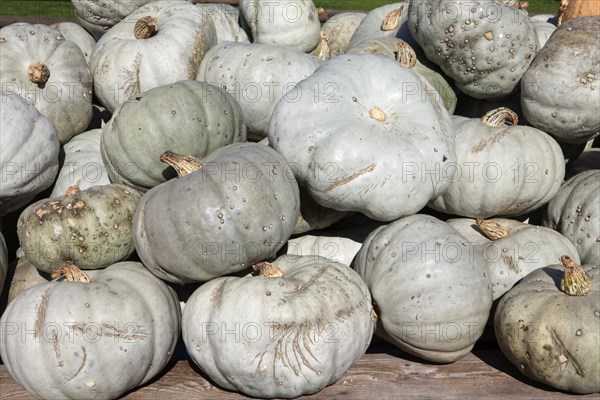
[0,262,181,400]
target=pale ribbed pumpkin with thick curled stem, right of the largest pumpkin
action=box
[429,108,565,218]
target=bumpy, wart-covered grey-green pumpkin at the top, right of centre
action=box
[408,0,538,99]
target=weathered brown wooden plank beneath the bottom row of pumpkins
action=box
[0,348,600,400]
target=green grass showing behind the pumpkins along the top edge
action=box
[0,0,560,19]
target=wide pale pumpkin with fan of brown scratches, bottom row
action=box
[182,256,376,398]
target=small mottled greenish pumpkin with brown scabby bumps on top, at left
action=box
[17,183,141,273]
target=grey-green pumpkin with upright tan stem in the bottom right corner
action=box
[494,257,600,394]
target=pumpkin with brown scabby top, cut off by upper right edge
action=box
[521,17,600,143]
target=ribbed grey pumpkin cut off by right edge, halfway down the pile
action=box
[542,169,600,265]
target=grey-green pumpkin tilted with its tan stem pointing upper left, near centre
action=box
[133,143,300,283]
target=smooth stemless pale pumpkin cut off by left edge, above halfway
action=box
[0,93,60,217]
